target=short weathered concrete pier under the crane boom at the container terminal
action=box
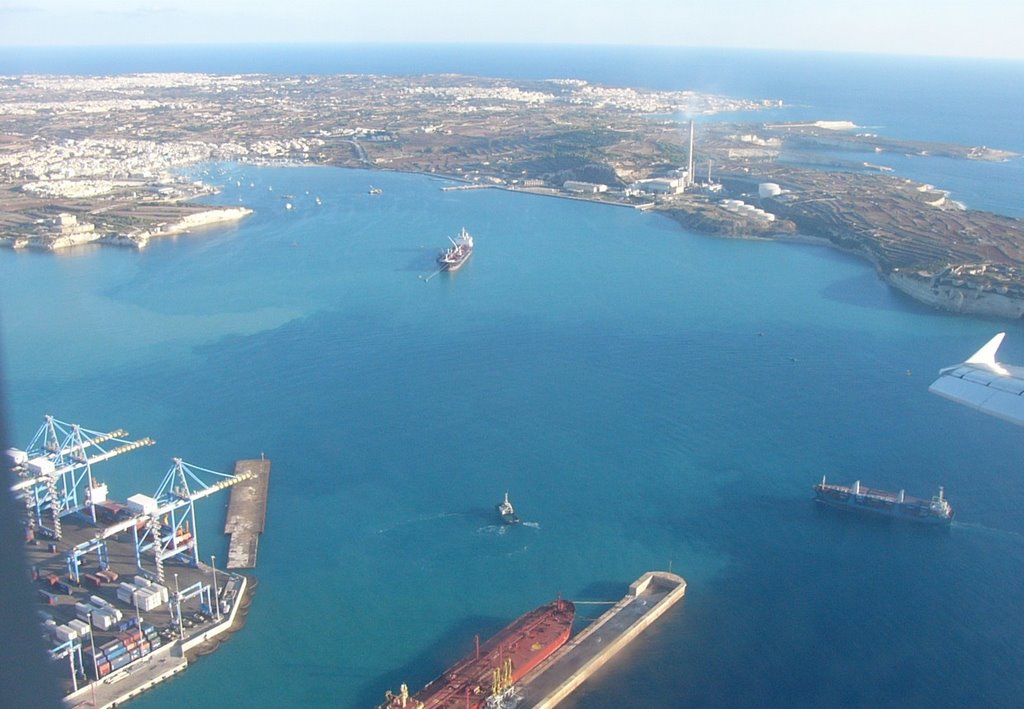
[224,457,270,569]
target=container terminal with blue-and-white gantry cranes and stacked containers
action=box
[6,416,270,707]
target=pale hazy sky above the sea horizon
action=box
[0,0,1024,59]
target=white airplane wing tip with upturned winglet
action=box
[928,332,1024,426]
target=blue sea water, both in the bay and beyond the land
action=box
[0,47,1024,708]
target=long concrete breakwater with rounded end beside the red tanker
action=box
[518,571,686,709]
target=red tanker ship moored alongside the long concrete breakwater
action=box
[378,598,575,709]
